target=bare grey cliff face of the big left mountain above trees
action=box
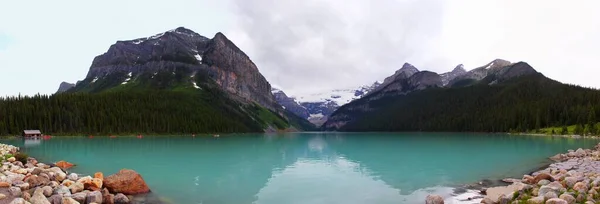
[76,27,281,111]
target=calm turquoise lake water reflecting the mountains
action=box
[0,133,598,204]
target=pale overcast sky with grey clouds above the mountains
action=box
[0,0,600,95]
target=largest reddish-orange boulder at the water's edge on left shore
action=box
[104,169,150,195]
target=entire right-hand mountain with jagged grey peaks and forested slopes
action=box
[322,59,600,132]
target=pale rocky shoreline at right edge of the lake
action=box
[426,144,600,204]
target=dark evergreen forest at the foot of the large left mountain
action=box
[0,90,304,135]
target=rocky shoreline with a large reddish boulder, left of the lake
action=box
[0,144,150,204]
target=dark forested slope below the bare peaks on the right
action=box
[329,74,600,132]
